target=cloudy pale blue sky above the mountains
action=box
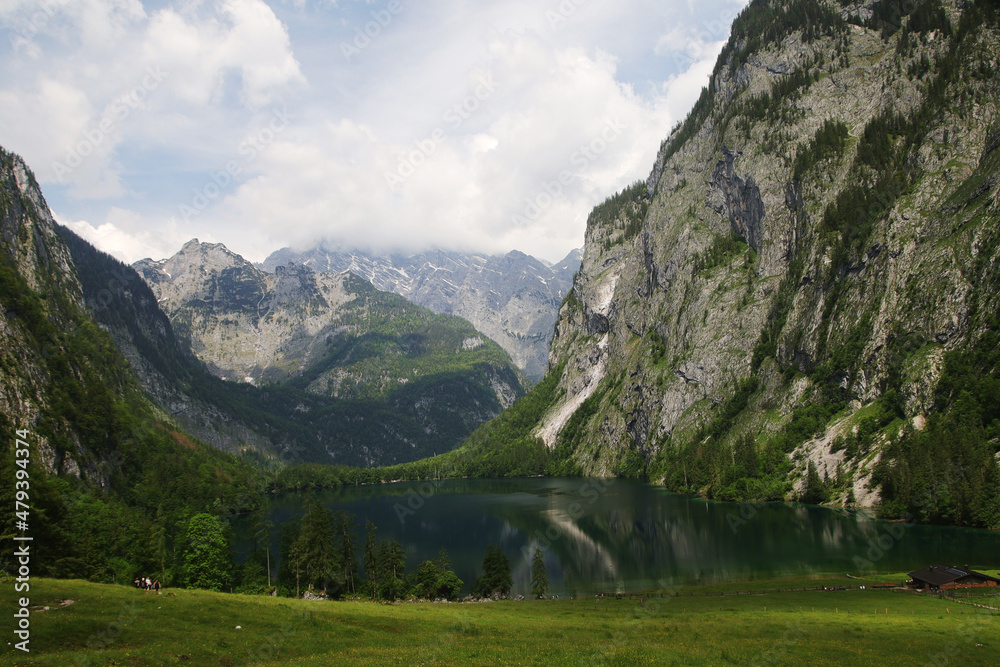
[0,0,746,262]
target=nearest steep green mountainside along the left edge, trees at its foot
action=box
[0,148,262,582]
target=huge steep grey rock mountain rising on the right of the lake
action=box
[468,0,1000,527]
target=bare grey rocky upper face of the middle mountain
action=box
[142,239,522,396]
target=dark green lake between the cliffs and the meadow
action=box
[244,478,1000,596]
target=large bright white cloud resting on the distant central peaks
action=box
[190,31,672,259]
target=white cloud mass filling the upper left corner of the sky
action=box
[0,0,305,200]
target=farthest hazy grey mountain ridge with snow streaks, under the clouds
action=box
[261,245,581,382]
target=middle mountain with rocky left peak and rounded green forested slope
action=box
[136,240,524,466]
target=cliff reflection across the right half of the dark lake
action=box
[472,481,1000,592]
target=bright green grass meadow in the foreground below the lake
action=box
[0,575,1000,667]
